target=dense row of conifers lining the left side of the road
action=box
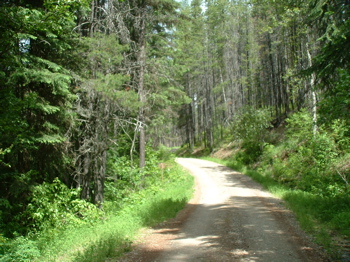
[0,0,187,237]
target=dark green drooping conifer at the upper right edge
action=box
[307,0,350,127]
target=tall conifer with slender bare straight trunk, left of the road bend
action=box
[113,0,183,168]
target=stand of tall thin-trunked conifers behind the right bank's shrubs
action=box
[177,0,327,149]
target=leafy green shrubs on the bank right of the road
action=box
[261,110,349,196]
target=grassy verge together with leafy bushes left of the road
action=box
[0,158,194,262]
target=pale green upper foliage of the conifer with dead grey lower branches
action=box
[82,34,140,115]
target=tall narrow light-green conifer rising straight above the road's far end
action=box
[175,0,205,150]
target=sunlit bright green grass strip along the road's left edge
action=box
[0,165,194,262]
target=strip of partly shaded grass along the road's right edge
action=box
[202,157,350,261]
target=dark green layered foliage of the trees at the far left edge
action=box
[0,1,87,236]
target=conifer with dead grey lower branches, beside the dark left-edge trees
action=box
[69,33,138,207]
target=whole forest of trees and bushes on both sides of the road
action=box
[0,0,350,261]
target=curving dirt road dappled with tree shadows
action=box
[121,158,327,262]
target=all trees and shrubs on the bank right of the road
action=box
[175,0,350,255]
